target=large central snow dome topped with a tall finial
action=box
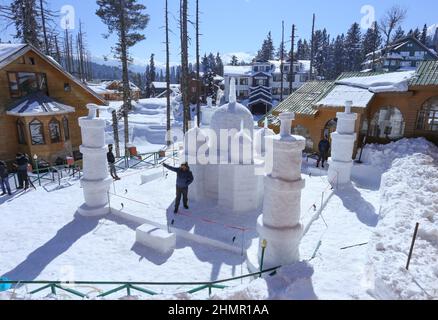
[210,78,254,151]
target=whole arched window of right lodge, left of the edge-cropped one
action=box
[370,107,405,140]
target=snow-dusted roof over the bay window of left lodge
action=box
[6,93,75,117]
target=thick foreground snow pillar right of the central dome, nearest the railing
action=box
[257,113,306,269]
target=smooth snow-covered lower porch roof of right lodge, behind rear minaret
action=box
[316,85,374,108]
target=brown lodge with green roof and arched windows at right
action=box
[259,61,438,151]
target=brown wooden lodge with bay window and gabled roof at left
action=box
[0,44,106,163]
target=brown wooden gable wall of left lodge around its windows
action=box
[0,51,102,161]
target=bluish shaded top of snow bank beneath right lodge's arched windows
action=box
[362,138,438,171]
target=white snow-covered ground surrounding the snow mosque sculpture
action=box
[0,99,438,299]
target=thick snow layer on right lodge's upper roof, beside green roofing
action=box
[336,71,415,93]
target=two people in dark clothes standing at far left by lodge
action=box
[0,153,30,196]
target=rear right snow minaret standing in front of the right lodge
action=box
[328,101,357,185]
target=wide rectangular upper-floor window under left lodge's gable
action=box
[8,72,48,98]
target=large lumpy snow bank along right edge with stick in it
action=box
[369,139,438,299]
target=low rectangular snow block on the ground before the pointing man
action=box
[136,224,176,254]
